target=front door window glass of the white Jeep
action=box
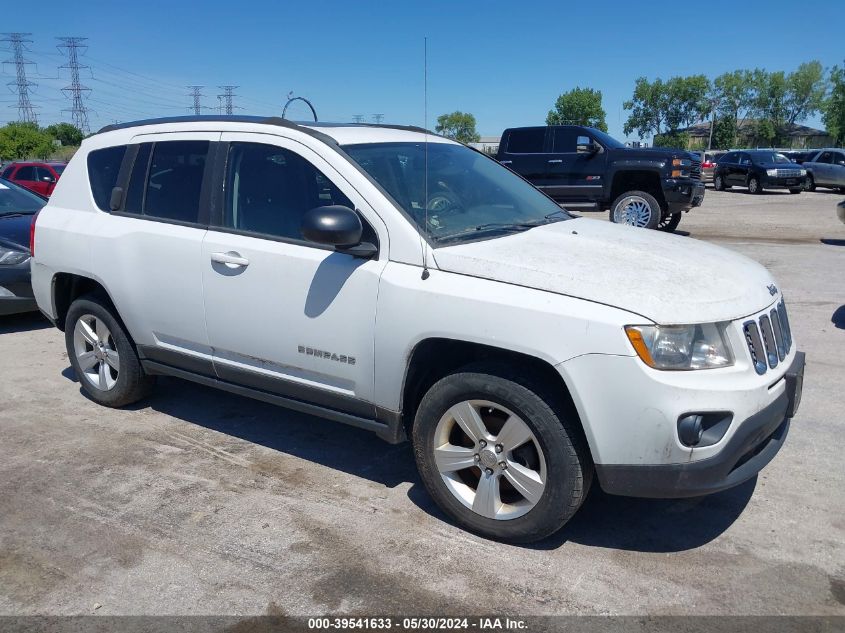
[223,143,354,241]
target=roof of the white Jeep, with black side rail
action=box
[97,115,451,145]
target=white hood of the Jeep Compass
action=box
[434,218,776,324]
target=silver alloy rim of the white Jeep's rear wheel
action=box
[73,314,120,391]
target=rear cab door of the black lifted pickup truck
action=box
[548,127,607,202]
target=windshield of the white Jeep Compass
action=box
[343,143,571,243]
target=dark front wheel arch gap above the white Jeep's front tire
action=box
[400,337,593,459]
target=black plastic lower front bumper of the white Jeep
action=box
[596,352,804,498]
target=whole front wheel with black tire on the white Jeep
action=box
[412,363,593,543]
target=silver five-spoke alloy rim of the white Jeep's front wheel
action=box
[434,400,546,520]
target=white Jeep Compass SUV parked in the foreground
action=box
[32,117,804,542]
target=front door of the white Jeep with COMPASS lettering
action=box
[202,133,387,418]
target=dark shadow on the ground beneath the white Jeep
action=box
[62,368,756,552]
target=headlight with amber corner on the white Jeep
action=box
[625,323,734,370]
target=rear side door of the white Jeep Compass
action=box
[88,132,220,376]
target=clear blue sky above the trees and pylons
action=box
[0,0,845,138]
